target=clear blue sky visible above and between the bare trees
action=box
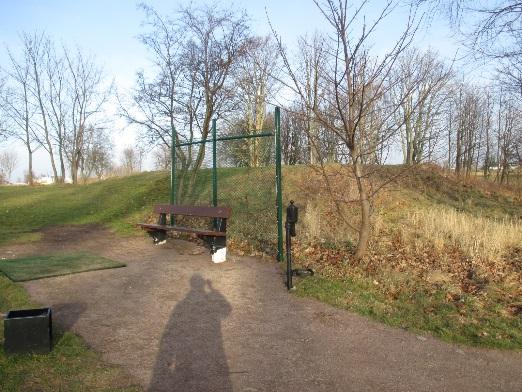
[0,0,456,180]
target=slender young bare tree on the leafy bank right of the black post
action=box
[279,0,416,258]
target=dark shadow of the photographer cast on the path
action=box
[149,274,232,392]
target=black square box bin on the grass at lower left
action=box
[4,308,53,354]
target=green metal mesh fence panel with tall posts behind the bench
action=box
[170,107,283,260]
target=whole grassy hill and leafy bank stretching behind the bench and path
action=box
[0,166,522,349]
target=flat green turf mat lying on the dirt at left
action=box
[0,252,125,282]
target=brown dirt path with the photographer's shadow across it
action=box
[4,227,522,392]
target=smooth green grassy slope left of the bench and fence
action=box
[0,173,168,242]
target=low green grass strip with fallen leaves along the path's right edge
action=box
[296,274,522,350]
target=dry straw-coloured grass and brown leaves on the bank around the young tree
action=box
[287,167,522,290]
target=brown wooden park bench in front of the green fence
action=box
[138,204,232,262]
